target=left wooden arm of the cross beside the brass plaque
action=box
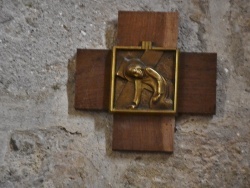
[75,49,111,110]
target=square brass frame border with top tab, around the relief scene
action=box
[109,41,179,114]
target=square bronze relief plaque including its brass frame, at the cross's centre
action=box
[110,42,179,114]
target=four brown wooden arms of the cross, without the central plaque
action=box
[75,11,217,152]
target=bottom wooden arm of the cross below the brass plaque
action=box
[113,114,175,151]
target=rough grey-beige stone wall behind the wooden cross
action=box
[0,0,250,188]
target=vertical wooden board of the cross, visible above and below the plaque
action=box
[112,12,178,152]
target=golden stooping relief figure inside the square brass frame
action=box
[116,59,173,109]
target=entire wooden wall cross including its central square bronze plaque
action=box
[75,11,217,152]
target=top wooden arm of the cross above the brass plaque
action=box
[117,11,178,48]
